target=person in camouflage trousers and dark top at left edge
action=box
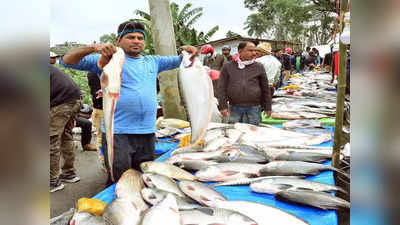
[49,65,82,192]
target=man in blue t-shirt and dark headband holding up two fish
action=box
[60,21,198,185]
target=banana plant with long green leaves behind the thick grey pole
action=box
[132,2,219,51]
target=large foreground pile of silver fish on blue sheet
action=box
[57,123,350,225]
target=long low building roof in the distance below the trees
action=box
[196,36,302,55]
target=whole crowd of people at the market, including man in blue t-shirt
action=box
[50,21,344,192]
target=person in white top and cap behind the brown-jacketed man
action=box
[256,42,282,96]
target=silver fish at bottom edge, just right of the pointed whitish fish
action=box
[180,207,257,225]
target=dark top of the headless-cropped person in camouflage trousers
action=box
[49,64,81,108]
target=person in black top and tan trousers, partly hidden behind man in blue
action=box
[87,72,104,165]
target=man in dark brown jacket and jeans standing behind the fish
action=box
[218,42,271,125]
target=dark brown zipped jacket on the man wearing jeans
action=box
[218,61,271,111]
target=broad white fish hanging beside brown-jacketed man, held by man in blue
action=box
[179,51,215,144]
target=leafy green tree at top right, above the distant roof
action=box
[244,0,335,44]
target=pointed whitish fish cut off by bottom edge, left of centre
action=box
[142,194,182,225]
